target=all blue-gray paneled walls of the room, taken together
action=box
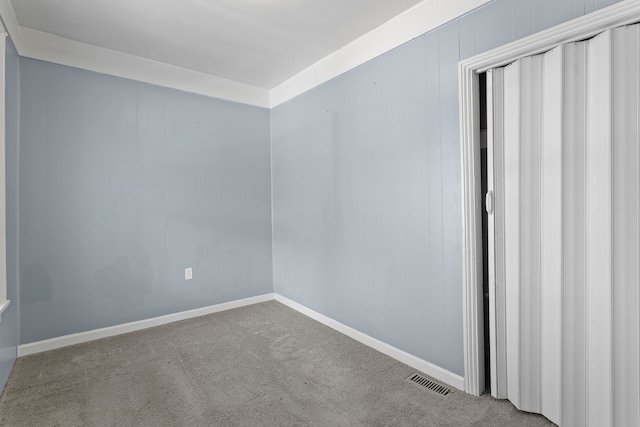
[0,0,615,384]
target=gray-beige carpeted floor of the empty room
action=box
[0,301,552,427]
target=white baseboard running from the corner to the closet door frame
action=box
[274,294,464,391]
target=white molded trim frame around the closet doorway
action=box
[459,0,640,396]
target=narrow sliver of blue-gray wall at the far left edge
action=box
[0,41,20,390]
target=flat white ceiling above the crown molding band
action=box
[11,0,421,89]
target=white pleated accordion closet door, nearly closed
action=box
[488,25,640,427]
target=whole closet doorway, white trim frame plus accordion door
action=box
[459,5,640,425]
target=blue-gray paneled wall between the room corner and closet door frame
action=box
[271,0,615,375]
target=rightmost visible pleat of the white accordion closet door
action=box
[608,25,640,426]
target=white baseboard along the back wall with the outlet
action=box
[18,294,274,357]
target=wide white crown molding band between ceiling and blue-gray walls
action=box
[0,0,490,108]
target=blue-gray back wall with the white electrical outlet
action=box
[17,58,273,343]
